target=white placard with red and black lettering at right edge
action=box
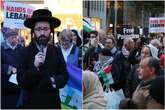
[149,17,165,33]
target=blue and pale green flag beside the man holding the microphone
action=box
[60,62,83,109]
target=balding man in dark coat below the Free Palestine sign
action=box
[110,37,134,93]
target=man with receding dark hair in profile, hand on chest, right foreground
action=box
[132,57,160,109]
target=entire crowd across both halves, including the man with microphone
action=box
[1,9,165,109]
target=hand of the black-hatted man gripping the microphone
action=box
[34,52,45,68]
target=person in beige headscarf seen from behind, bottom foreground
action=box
[83,71,107,109]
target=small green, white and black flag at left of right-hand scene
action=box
[83,18,95,32]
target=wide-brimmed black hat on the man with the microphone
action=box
[24,9,61,28]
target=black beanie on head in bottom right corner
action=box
[149,76,164,105]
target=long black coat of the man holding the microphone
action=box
[17,44,68,108]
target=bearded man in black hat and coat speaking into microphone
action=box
[17,9,68,109]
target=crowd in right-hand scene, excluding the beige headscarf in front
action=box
[83,30,165,109]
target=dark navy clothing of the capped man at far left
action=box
[1,42,24,109]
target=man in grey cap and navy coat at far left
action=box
[1,28,24,108]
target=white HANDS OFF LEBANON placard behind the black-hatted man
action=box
[4,2,34,29]
